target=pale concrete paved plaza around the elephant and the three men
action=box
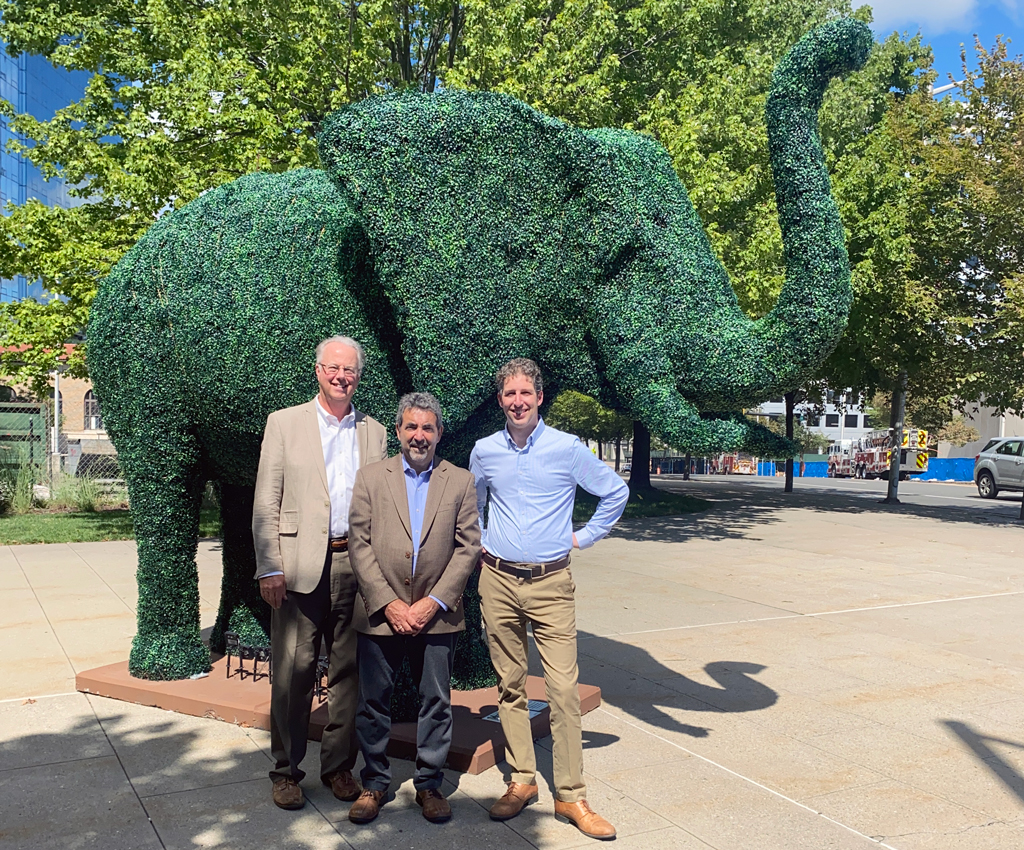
[0,481,1024,850]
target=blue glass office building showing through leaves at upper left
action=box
[0,45,89,301]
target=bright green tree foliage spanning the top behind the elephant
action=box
[0,0,1024,430]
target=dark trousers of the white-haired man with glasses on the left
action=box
[270,552,358,782]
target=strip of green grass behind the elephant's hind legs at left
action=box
[0,508,220,546]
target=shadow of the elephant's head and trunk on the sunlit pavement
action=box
[579,632,778,737]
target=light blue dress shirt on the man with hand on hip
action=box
[469,420,630,563]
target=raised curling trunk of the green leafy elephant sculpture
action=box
[756,18,873,386]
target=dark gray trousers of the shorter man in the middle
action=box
[355,632,459,791]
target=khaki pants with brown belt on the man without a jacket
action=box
[480,564,587,803]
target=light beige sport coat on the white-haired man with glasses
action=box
[253,399,387,593]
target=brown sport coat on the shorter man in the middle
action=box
[348,455,480,637]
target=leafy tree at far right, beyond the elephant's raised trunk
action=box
[822,38,1024,501]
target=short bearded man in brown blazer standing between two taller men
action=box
[348,392,480,823]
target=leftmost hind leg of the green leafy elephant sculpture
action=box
[119,430,210,679]
